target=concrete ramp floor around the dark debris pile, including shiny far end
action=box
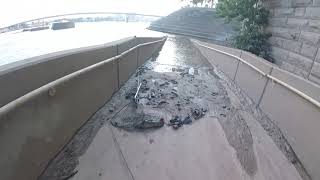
[42,37,302,180]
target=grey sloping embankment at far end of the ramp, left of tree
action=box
[149,8,234,44]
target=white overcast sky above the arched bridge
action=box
[0,0,185,27]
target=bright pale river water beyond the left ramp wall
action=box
[0,22,163,66]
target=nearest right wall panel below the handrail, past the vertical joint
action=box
[260,82,320,179]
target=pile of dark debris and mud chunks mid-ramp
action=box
[111,66,209,130]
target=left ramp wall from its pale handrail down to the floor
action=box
[0,38,165,180]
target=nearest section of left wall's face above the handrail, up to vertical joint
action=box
[0,46,116,107]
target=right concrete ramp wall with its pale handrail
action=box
[193,41,320,179]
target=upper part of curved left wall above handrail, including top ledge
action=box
[0,37,139,107]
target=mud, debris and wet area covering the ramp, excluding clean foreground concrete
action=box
[39,37,303,180]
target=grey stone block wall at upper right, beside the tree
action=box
[264,0,320,84]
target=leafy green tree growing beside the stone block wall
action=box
[216,0,272,61]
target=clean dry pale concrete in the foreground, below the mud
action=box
[73,114,301,180]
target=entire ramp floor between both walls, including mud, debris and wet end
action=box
[39,36,308,180]
